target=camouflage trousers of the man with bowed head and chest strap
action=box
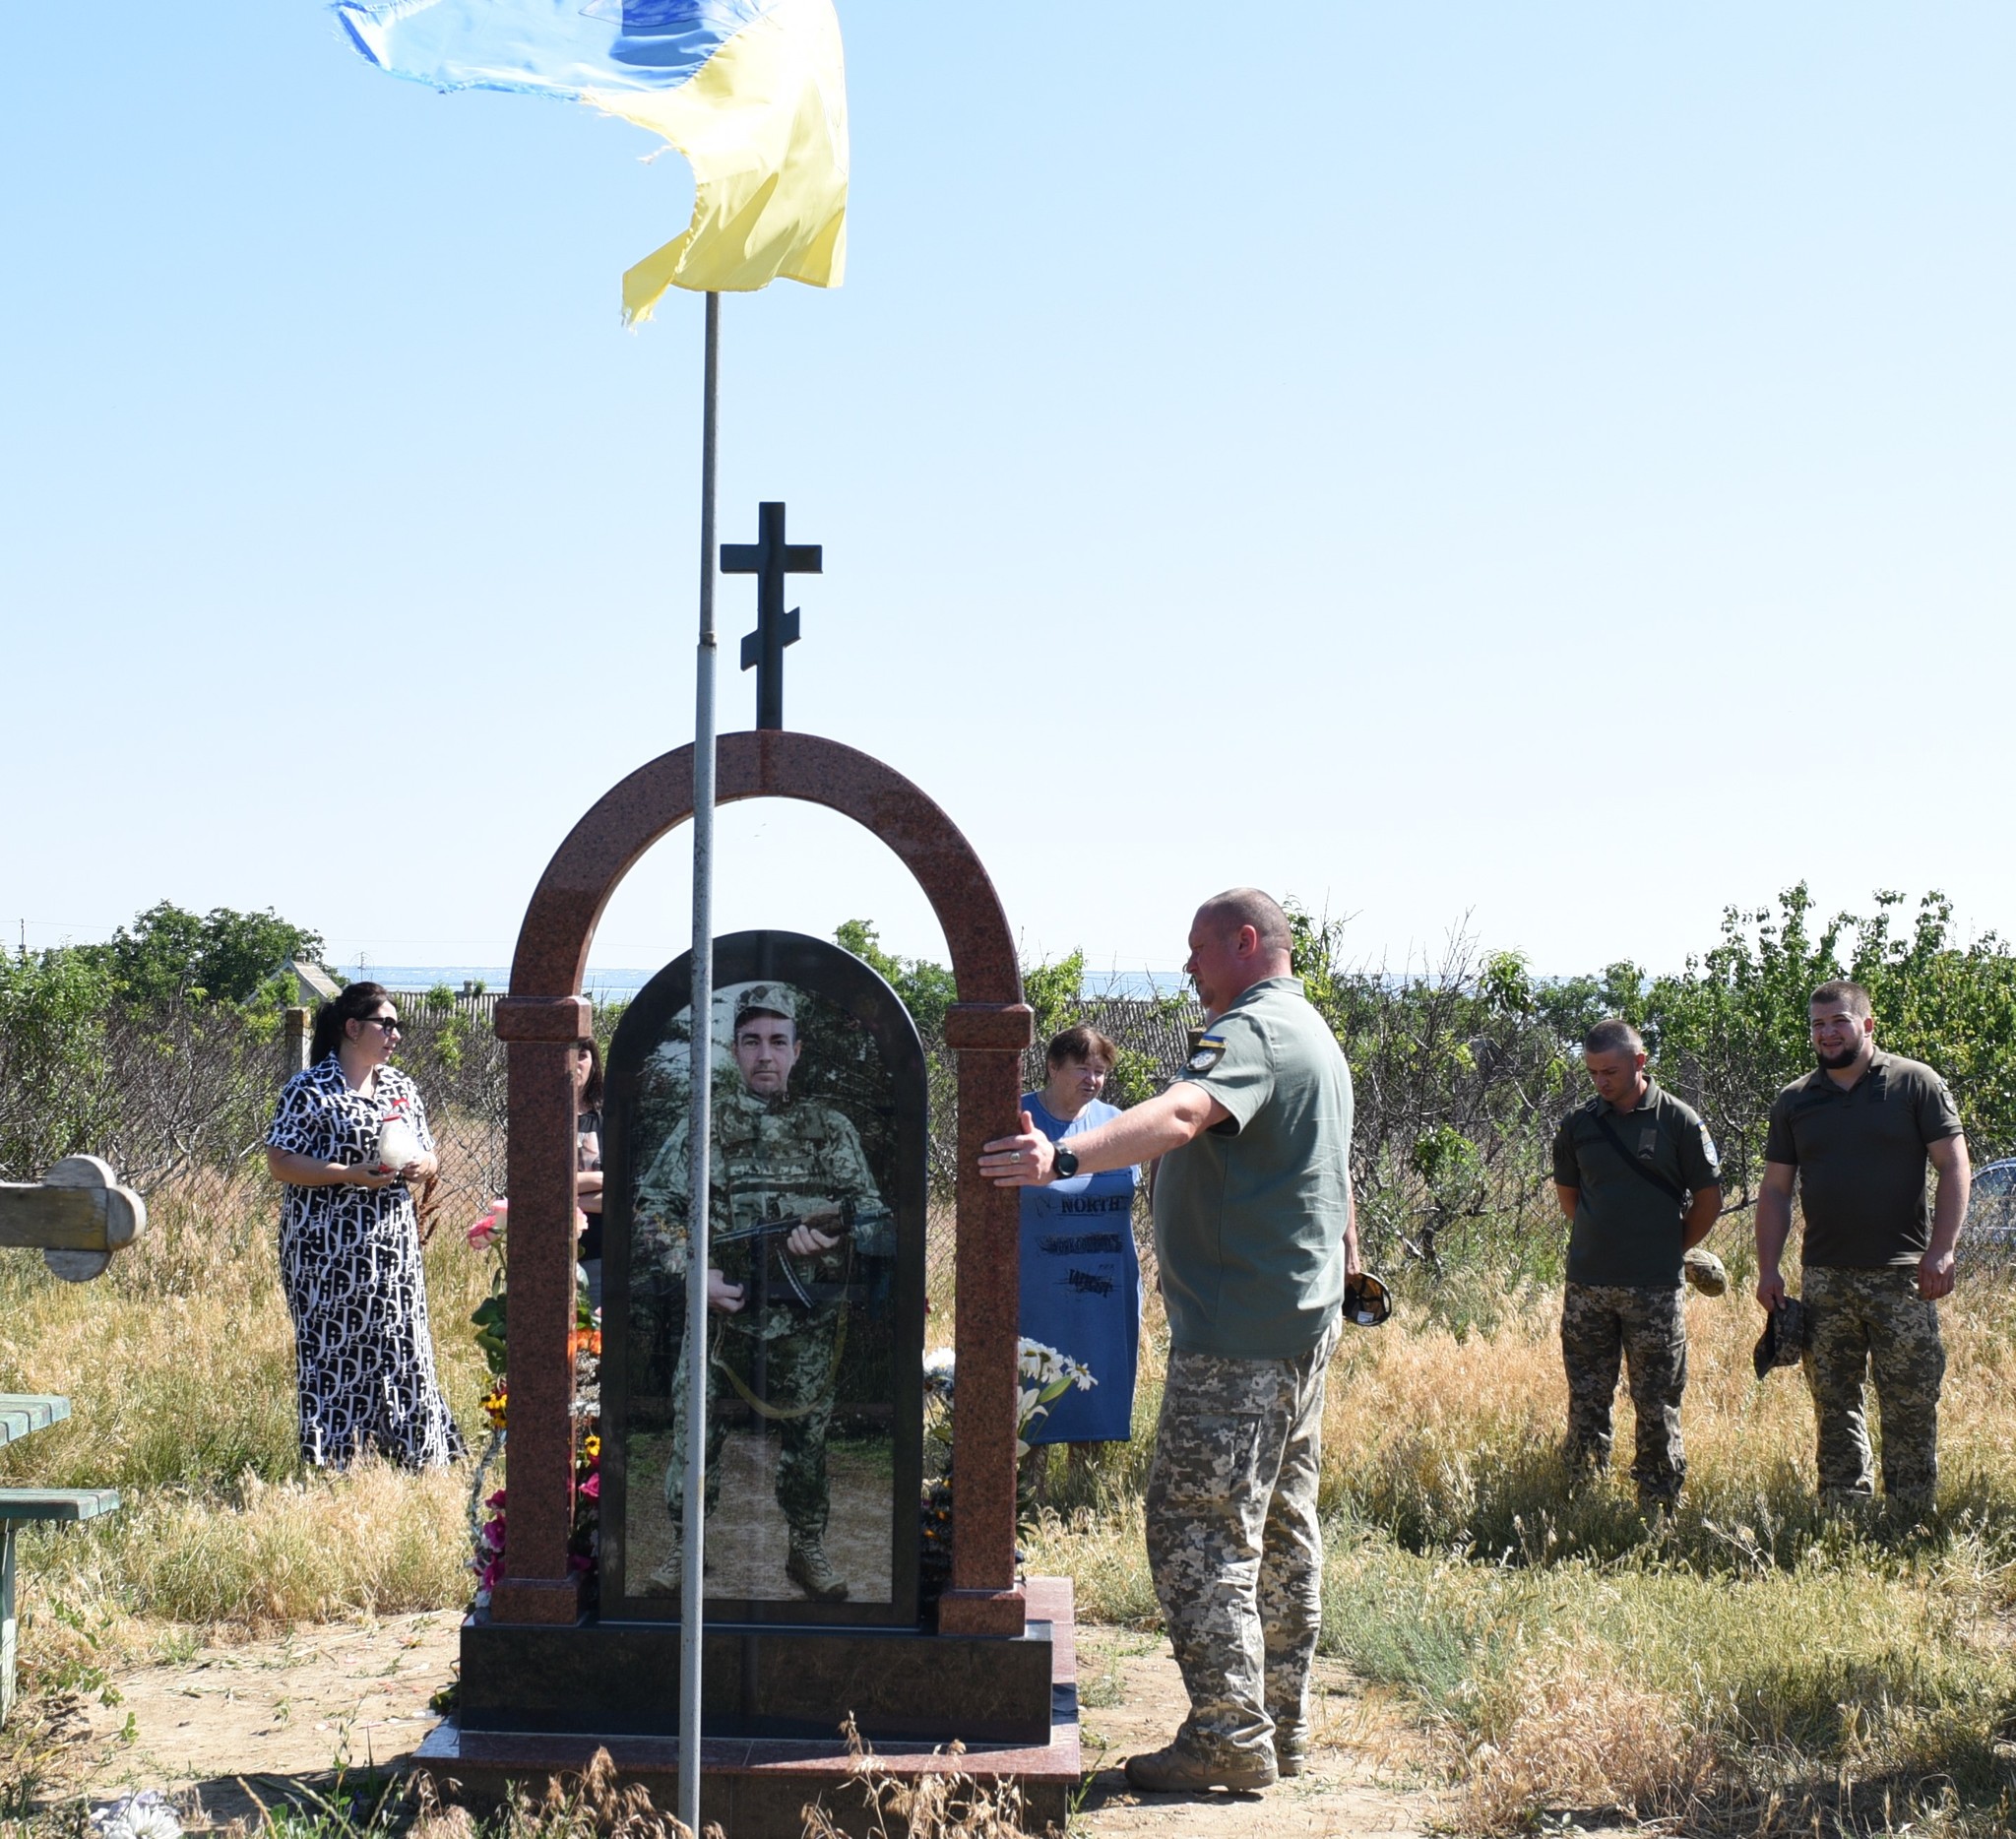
[1560,1283,1687,1502]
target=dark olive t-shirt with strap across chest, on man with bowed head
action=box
[1554,1081,1722,1291]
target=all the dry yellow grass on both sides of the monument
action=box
[0,1177,2016,1835]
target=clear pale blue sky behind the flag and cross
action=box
[0,0,2016,972]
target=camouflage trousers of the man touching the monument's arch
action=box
[1147,1325,1339,1762]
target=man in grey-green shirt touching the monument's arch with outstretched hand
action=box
[979,887,1358,1793]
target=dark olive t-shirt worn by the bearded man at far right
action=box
[1764,1050,1960,1270]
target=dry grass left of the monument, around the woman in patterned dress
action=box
[0,1175,488,1685]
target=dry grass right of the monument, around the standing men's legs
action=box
[1024,1272,2016,1835]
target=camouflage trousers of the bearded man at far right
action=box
[1800,1264,1945,1508]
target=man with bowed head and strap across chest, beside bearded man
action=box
[1554,1018,1722,1512]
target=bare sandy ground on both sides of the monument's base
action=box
[42,1614,1435,1839]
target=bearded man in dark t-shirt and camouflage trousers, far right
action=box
[1758,980,1970,1516]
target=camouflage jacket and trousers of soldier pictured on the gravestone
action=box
[635,1091,895,1541]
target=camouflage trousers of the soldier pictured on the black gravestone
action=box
[665,1312,843,1539]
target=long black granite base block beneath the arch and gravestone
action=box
[460,1616,1050,1744]
